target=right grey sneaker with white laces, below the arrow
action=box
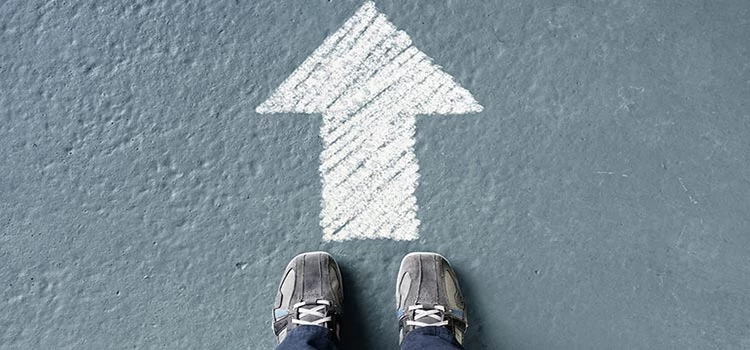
[396,253,468,344]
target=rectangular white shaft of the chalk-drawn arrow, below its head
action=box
[320,110,419,241]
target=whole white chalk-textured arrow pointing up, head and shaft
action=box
[256,2,482,241]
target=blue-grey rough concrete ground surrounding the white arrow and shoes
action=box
[0,0,750,349]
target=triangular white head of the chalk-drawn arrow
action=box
[256,1,482,115]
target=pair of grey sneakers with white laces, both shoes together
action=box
[273,252,468,344]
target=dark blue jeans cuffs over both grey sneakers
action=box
[276,326,464,350]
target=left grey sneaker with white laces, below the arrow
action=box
[273,252,344,343]
